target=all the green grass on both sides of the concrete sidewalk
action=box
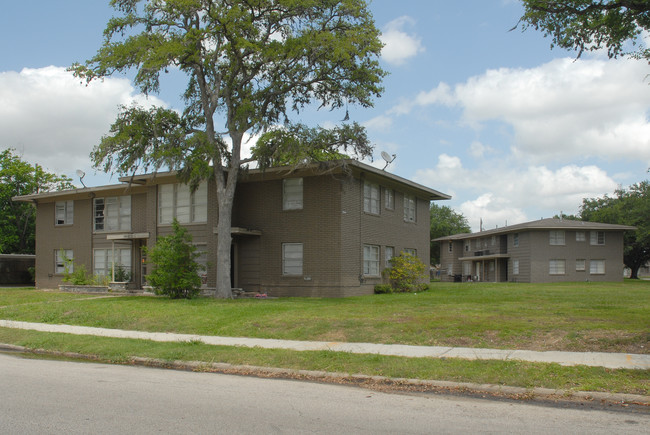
[0,281,650,395]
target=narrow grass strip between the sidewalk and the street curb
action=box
[0,328,650,395]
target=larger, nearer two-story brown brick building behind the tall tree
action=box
[15,160,450,297]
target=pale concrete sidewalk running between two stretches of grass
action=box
[0,320,650,370]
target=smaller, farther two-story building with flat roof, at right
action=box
[436,219,635,282]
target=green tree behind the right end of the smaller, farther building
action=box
[580,181,650,278]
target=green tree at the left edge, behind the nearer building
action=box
[0,148,74,254]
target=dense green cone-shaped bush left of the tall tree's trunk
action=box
[146,219,203,299]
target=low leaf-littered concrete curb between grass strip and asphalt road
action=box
[0,343,650,407]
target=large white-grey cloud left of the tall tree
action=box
[0,66,163,181]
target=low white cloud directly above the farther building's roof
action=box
[415,154,617,230]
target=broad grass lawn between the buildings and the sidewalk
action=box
[0,281,650,354]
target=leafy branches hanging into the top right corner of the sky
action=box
[520,0,650,62]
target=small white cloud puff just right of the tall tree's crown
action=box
[381,16,425,65]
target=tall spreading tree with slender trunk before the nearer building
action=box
[72,0,385,297]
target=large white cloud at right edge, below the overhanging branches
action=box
[392,58,650,163]
